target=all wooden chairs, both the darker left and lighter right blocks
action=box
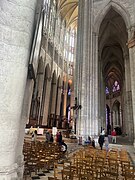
[23,142,135,180]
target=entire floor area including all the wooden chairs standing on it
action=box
[24,136,135,180]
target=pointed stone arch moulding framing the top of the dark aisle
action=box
[93,1,131,34]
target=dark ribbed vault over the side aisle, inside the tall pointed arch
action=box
[99,8,127,93]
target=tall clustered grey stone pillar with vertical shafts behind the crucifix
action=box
[75,0,99,136]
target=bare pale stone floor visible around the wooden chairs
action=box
[24,136,135,180]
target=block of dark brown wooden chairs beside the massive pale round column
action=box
[23,141,62,176]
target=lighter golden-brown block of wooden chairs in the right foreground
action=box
[49,147,135,180]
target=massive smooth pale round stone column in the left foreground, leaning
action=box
[0,0,36,180]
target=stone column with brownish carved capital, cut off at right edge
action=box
[128,27,135,146]
